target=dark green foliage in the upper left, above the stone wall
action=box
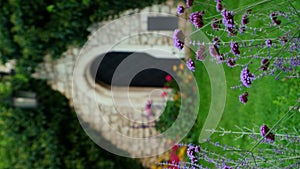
[0,0,164,67]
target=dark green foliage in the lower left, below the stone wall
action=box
[0,77,141,169]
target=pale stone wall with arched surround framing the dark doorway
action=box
[34,1,188,166]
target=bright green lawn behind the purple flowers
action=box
[155,0,300,168]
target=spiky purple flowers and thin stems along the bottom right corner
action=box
[156,125,300,169]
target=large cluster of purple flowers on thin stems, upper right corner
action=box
[174,0,300,103]
